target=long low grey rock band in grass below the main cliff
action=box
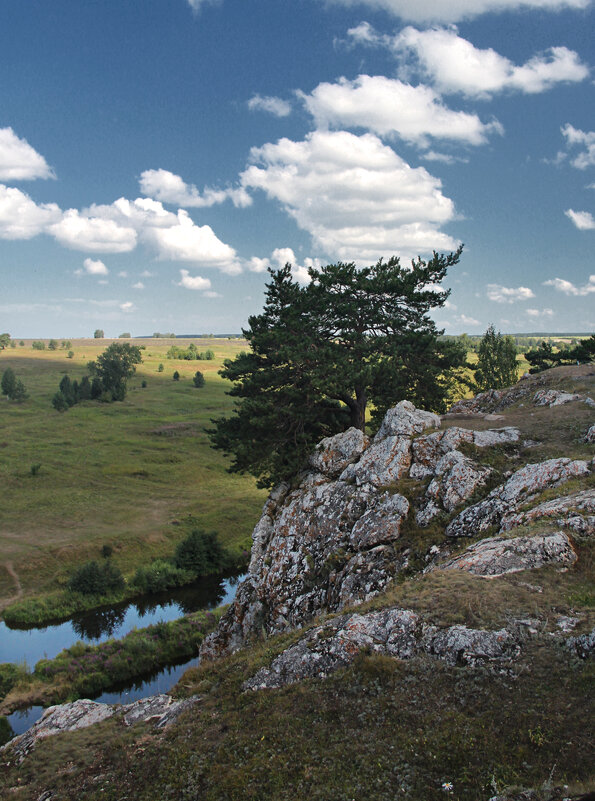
[244,609,520,690]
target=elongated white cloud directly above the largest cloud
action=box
[300,75,502,146]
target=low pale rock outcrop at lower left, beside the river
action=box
[0,695,198,762]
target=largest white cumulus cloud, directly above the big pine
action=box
[240,131,457,263]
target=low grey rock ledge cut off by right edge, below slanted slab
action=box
[500,489,595,536]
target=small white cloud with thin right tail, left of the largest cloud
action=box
[139,169,252,208]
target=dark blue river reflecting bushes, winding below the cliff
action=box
[0,576,244,734]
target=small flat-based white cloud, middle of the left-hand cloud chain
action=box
[47,209,137,253]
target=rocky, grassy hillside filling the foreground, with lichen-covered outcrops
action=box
[0,366,595,801]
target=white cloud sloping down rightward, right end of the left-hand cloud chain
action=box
[143,209,242,275]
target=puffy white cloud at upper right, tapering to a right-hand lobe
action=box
[392,27,589,97]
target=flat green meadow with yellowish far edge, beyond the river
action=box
[0,338,265,608]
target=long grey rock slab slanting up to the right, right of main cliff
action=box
[446,457,589,537]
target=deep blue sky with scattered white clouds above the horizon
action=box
[0,0,595,337]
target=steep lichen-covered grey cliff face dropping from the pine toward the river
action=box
[201,401,440,657]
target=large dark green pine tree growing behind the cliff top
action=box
[209,246,466,486]
